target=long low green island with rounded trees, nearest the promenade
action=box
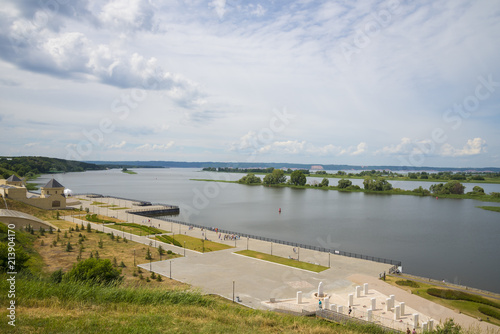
[192,169,500,208]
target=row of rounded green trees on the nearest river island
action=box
[238,169,500,198]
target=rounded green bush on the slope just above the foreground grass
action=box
[63,258,123,284]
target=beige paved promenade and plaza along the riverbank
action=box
[68,196,500,333]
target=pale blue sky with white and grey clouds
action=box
[0,0,500,167]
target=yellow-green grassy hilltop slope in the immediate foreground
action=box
[0,277,376,334]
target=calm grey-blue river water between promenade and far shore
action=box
[37,169,500,293]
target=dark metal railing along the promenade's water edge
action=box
[74,194,401,272]
